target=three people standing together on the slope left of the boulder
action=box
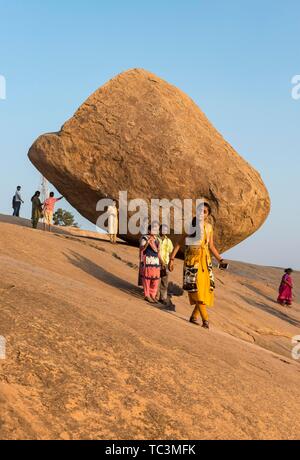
[12,185,63,232]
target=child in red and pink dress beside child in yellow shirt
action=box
[140,222,161,303]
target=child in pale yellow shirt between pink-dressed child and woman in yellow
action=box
[158,225,175,311]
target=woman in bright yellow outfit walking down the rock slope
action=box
[169,202,223,329]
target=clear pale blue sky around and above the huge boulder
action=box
[0,0,300,268]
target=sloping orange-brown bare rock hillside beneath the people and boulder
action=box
[0,217,300,439]
